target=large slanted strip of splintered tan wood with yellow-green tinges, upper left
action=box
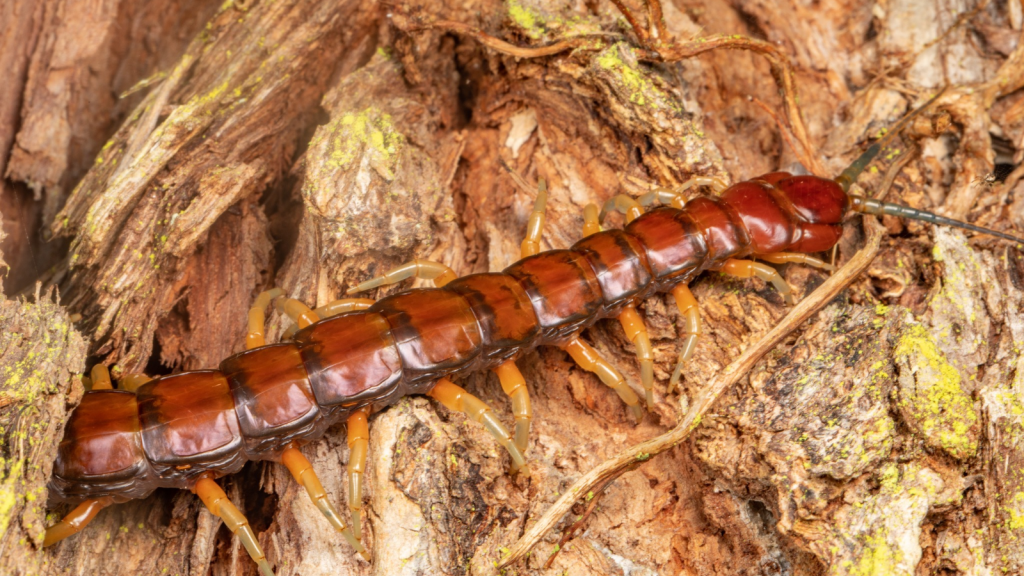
[48,1,374,372]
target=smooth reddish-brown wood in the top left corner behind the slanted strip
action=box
[0,0,216,293]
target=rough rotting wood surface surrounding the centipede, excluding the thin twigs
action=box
[0,0,1024,576]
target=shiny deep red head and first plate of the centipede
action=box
[722,172,850,254]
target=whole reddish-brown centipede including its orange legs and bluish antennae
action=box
[46,91,1024,574]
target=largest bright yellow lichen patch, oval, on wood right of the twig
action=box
[895,325,978,459]
